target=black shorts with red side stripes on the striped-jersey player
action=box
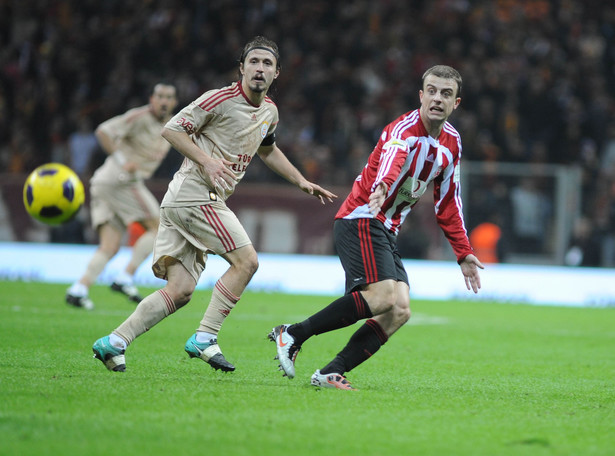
[333,218,408,293]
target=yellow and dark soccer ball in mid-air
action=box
[23,163,85,225]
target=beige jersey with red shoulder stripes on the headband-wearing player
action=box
[162,82,278,207]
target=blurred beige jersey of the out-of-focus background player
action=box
[90,105,171,185]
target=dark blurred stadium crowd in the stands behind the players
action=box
[0,0,615,266]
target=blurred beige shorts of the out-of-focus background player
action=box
[90,182,160,230]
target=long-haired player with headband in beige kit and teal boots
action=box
[92,37,336,371]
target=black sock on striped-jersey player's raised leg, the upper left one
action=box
[288,291,373,345]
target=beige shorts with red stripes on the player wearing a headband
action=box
[152,201,252,282]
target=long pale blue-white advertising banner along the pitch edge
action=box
[0,242,615,307]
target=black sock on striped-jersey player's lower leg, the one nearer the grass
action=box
[320,319,388,375]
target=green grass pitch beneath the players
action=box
[0,282,615,456]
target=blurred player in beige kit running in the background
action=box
[66,83,177,309]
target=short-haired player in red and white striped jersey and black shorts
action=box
[269,65,483,389]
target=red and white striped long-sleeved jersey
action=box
[336,109,472,261]
